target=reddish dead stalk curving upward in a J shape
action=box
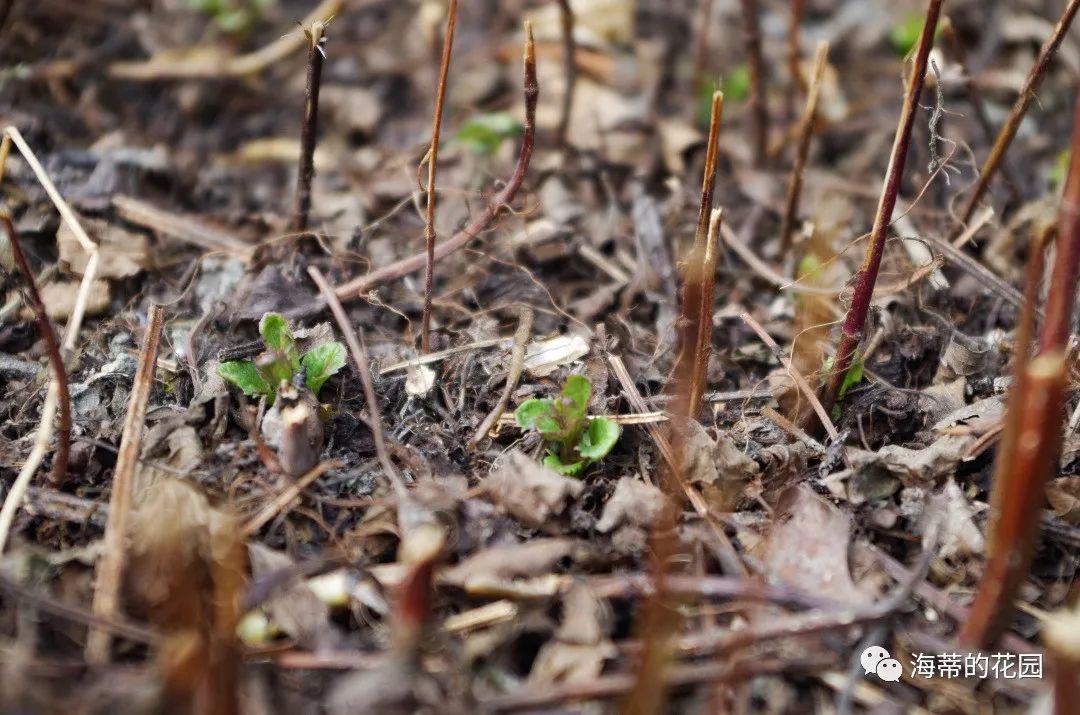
[334,23,540,300]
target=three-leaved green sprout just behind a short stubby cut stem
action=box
[217,313,346,402]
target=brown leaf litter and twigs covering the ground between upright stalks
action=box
[0,0,1080,713]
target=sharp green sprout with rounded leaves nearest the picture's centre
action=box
[514,375,622,475]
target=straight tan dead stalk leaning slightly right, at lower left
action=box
[86,306,165,664]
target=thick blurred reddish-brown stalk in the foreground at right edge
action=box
[958,89,1080,648]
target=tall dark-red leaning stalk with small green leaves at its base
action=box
[821,0,944,425]
